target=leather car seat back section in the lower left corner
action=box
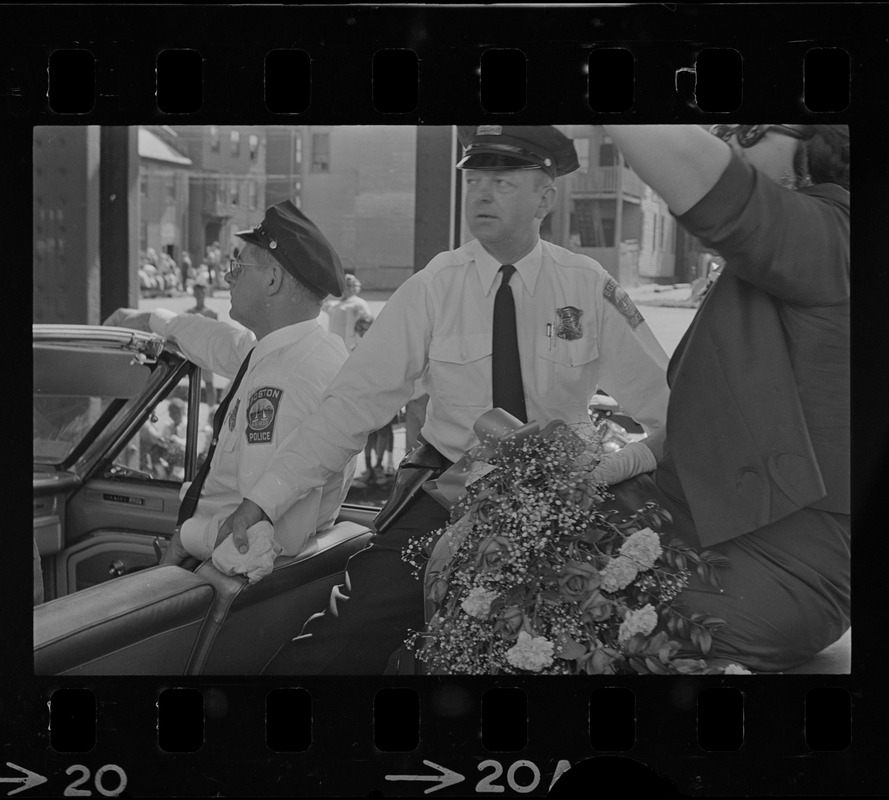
[34,566,216,675]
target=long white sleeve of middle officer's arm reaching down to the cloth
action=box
[245,275,434,523]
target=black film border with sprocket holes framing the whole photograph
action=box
[6,4,889,796]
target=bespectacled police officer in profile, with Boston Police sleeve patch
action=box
[106,200,355,576]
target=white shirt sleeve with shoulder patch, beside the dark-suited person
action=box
[597,276,670,450]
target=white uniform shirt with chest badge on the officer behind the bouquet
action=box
[246,241,669,521]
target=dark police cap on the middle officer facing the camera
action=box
[457,125,580,178]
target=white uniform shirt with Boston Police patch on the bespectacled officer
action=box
[151,309,355,558]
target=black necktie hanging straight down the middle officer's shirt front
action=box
[491,264,528,422]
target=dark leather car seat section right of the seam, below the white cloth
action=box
[188,521,372,675]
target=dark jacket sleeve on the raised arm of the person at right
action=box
[677,154,850,306]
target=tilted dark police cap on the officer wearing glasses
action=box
[235,200,346,296]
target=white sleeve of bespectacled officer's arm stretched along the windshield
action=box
[150,308,256,378]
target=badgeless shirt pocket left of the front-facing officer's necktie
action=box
[428,334,491,408]
